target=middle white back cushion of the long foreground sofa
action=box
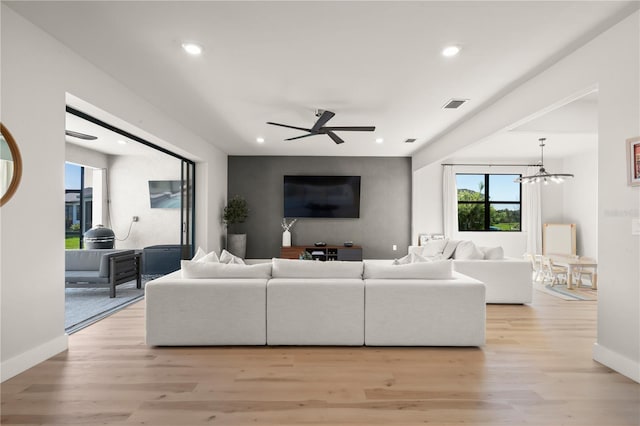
[273,259,363,279]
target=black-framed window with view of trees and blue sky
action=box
[456,174,522,232]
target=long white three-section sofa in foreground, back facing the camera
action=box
[145,259,486,346]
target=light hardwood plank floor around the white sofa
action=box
[1,291,640,426]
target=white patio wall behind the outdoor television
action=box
[108,152,182,249]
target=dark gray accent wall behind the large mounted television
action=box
[227,156,411,259]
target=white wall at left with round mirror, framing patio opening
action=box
[0,3,227,380]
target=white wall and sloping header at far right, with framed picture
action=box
[412,12,640,381]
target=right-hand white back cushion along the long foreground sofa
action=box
[364,260,453,280]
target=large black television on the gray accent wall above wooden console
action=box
[284,176,360,218]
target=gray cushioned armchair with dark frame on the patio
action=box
[65,249,142,297]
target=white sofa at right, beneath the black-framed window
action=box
[409,240,533,304]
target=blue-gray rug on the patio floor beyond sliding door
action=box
[64,275,161,334]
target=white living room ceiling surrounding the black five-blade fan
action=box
[6,1,635,156]
